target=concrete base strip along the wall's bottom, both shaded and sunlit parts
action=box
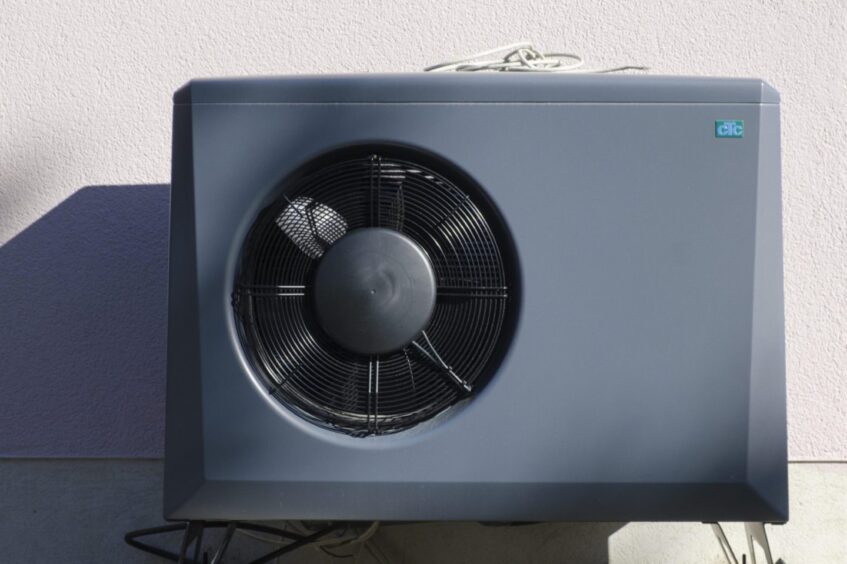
[0,459,847,564]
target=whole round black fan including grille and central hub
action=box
[232,146,517,436]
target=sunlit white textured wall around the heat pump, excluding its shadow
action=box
[0,0,847,563]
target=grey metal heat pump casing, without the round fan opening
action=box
[165,74,788,522]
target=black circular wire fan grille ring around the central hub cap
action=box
[232,147,517,436]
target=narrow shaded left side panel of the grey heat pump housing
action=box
[164,106,203,516]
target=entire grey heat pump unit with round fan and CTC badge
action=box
[165,73,788,522]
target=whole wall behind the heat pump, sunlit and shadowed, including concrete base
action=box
[0,0,847,564]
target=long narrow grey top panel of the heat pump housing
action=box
[174,73,779,104]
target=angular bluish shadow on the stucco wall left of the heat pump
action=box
[0,184,170,457]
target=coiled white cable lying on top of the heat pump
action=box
[424,42,648,73]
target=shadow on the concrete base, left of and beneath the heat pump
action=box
[0,460,628,564]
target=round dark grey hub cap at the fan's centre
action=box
[315,227,435,355]
